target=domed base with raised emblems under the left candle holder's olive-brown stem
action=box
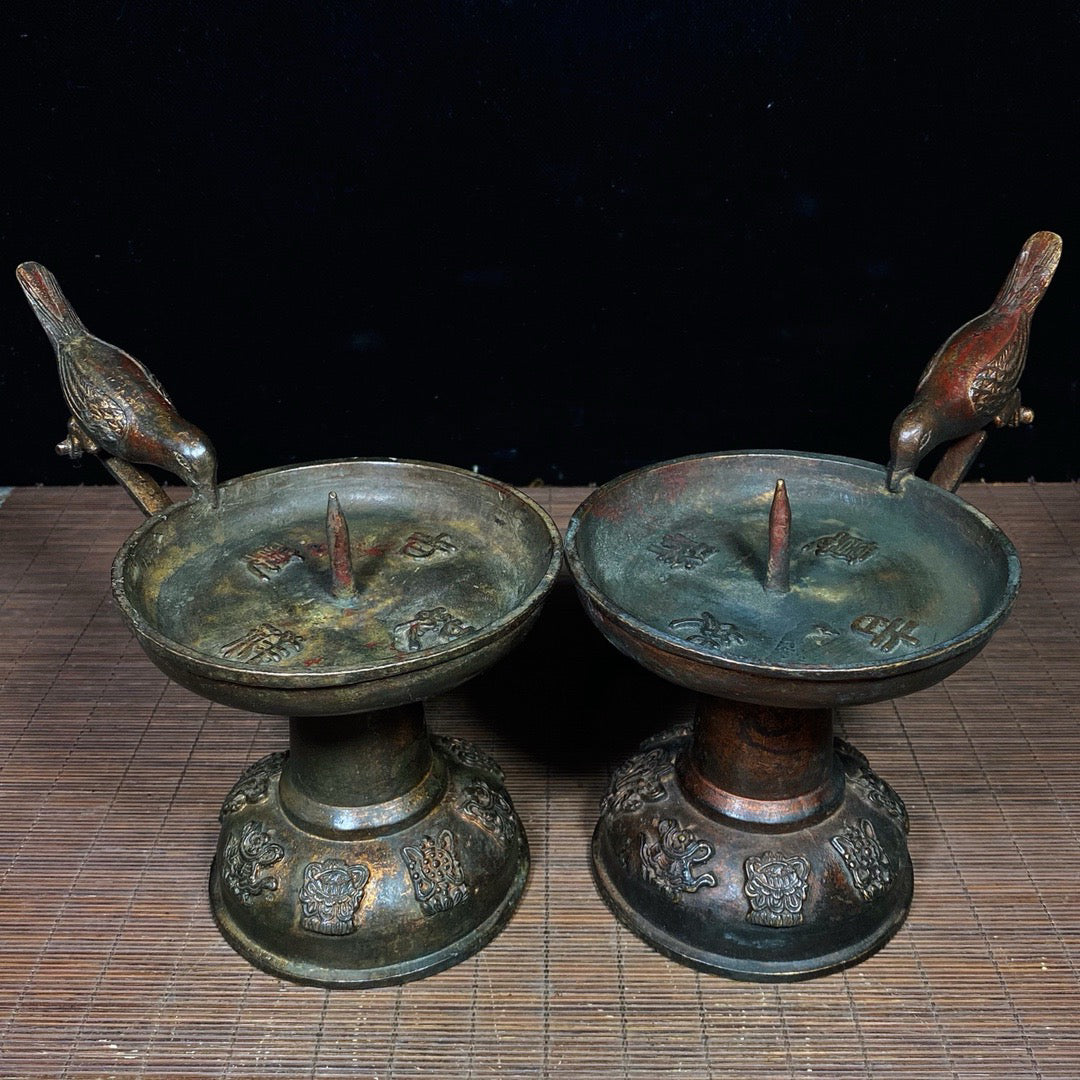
[210,737,528,988]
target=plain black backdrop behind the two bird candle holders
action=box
[0,0,1080,484]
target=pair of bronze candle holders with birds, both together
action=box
[17,232,1061,987]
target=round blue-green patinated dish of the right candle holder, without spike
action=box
[567,451,1020,707]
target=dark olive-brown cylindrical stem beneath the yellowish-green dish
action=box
[280,704,445,837]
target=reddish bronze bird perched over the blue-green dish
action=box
[887,232,1062,491]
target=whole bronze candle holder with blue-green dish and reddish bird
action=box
[566,233,1061,981]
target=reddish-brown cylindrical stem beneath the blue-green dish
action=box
[679,694,843,828]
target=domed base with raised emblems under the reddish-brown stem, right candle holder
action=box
[593,728,913,982]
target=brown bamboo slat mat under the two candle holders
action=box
[0,484,1080,1080]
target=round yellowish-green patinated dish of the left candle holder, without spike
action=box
[113,460,558,716]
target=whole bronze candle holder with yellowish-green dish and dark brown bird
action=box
[18,264,562,987]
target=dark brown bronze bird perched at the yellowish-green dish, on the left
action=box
[15,262,217,505]
